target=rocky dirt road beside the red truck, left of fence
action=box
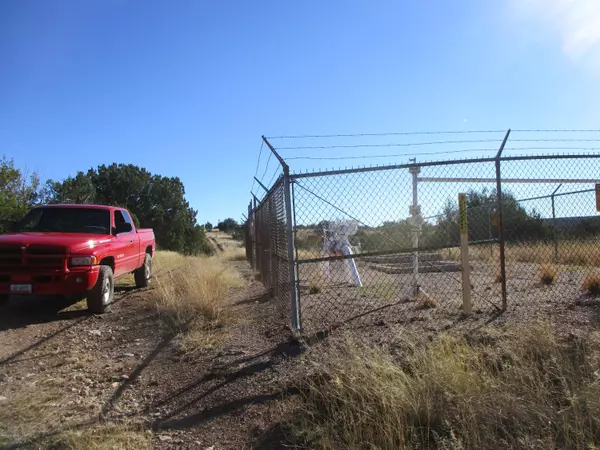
[0,263,300,450]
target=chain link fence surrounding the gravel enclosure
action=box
[241,137,600,332]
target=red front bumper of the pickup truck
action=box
[0,266,99,295]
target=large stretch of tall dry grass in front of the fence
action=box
[300,325,600,449]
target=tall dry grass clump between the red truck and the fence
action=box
[151,252,243,351]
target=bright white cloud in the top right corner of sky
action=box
[511,0,600,66]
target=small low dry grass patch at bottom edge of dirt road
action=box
[46,424,153,450]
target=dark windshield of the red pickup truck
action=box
[17,208,110,234]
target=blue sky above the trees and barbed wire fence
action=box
[0,0,600,222]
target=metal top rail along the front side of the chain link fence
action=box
[290,153,600,180]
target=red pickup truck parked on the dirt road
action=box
[0,205,155,314]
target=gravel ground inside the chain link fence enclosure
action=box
[299,261,599,333]
